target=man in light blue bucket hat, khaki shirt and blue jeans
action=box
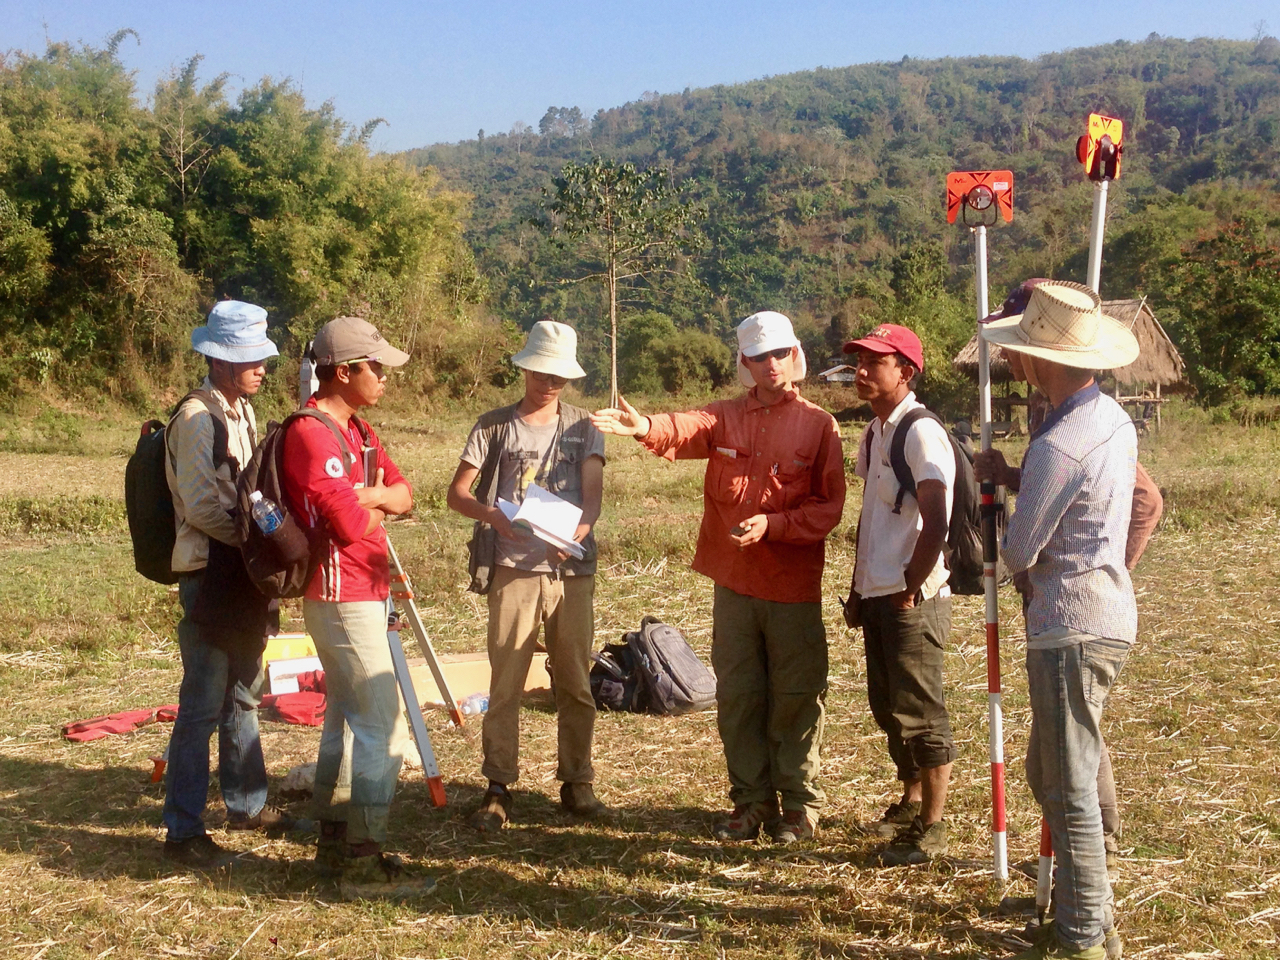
[164,300,293,869]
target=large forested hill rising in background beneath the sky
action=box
[406,35,1280,407]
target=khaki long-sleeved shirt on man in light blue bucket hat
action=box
[165,376,257,573]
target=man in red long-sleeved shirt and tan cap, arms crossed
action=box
[283,316,434,899]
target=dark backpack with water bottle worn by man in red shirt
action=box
[236,407,369,600]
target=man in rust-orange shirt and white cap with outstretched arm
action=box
[591,311,845,844]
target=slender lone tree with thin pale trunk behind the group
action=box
[536,156,700,403]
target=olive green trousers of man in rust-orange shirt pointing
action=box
[712,584,827,810]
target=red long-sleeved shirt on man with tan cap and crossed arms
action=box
[283,397,408,603]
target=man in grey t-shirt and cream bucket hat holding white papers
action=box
[448,320,605,832]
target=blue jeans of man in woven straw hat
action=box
[1027,634,1129,950]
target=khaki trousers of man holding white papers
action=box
[480,567,595,783]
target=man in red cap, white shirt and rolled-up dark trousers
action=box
[845,324,956,865]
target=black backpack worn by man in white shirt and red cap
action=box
[888,407,1005,596]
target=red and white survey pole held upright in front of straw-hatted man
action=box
[973,224,1009,881]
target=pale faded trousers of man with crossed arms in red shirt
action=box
[302,600,408,844]
